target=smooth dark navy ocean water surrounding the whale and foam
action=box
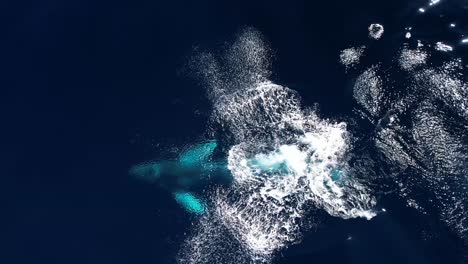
[10,0,468,264]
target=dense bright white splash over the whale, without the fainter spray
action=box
[216,83,375,256]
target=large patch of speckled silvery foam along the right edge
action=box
[344,28,468,246]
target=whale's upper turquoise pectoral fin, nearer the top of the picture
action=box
[179,140,218,166]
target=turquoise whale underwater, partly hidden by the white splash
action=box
[130,140,345,215]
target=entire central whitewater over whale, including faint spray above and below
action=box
[179,29,376,263]
